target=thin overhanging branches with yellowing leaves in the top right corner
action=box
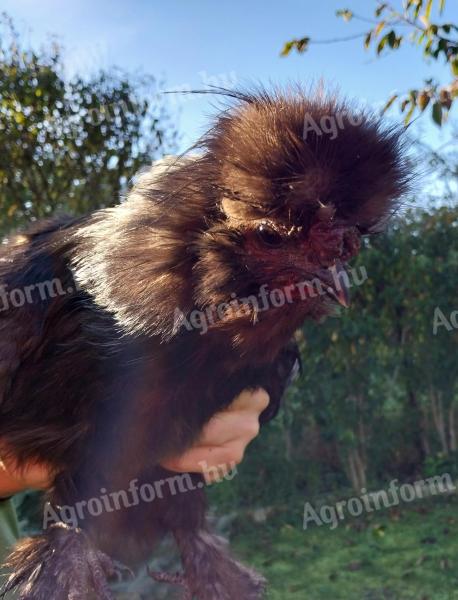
[282,0,458,126]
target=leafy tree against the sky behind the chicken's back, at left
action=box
[0,15,174,235]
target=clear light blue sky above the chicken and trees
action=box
[0,0,458,156]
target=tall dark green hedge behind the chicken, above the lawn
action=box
[216,207,458,508]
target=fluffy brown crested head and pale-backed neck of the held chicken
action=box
[70,89,408,354]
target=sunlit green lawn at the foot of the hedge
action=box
[233,497,458,600]
